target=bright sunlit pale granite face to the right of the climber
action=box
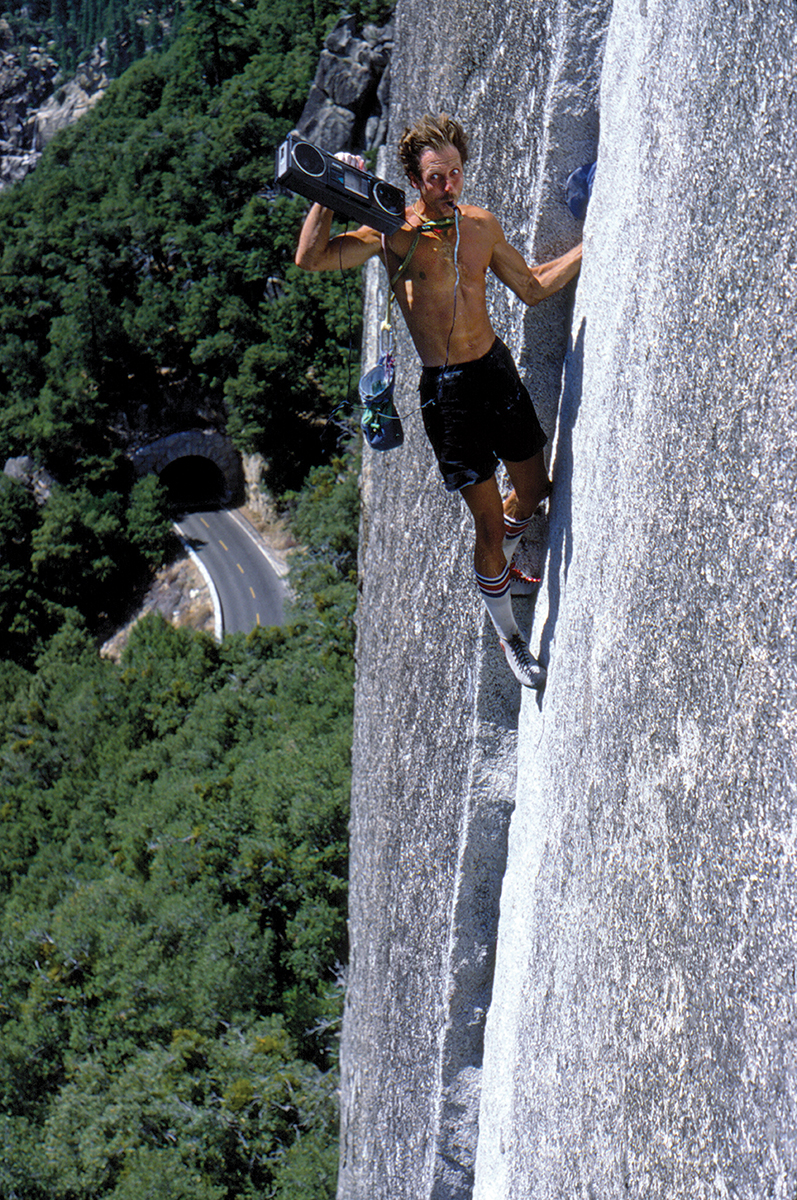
[474,0,797,1200]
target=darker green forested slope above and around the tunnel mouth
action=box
[0,0,386,664]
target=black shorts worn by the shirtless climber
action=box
[419,337,547,492]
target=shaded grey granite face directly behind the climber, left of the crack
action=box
[338,0,607,1200]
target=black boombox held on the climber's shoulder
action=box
[276,133,405,233]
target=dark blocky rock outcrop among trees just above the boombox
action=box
[296,17,392,154]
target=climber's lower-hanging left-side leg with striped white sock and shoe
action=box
[461,475,545,688]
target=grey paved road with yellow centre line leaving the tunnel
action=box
[175,509,286,634]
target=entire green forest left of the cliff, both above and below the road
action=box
[0,0,384,1200]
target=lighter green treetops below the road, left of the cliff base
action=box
[0,460,358,1200]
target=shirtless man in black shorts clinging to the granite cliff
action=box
[296,114,581,688]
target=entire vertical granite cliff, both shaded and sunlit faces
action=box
[338,0,797,1200]
